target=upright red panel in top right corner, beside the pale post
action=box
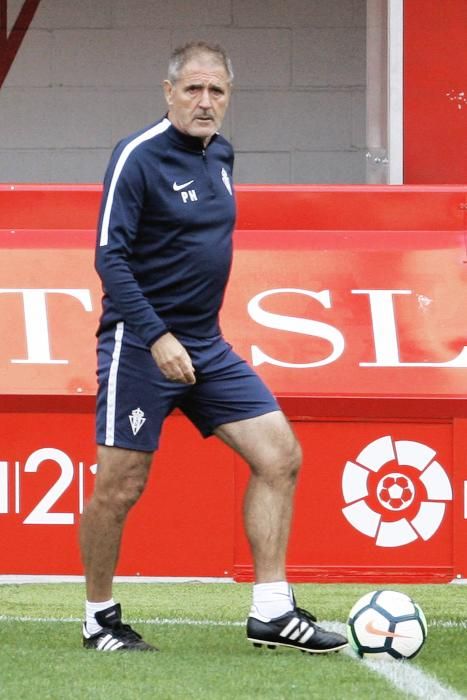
[404,0,467,183]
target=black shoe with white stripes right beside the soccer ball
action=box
[246,607,347,654]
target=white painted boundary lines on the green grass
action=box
[0,615,467,700]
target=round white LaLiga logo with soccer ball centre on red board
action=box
[342,435,452,547]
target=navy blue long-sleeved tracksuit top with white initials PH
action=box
[96,118,235,347]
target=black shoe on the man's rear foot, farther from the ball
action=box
[83,603,159,651]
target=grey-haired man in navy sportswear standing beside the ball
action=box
[81,42,346,652]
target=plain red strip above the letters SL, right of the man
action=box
[236,185,466,231]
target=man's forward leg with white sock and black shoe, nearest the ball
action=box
[216,411,347,654]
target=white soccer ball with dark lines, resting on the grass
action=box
[347,590,427,659]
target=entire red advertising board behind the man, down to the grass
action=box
[0,186,467,581]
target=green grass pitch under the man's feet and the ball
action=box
[0,583,467,700]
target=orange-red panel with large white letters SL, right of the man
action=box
[223,231,467,404]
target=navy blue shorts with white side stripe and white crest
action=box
[96,322,280,452]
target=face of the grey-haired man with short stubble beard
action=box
[164,53,231,146]
